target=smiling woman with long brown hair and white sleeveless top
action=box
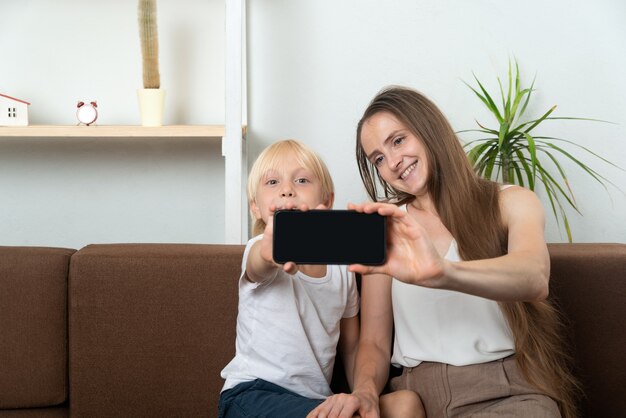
[309,87,577,418]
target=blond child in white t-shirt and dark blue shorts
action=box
[219,140,422,418]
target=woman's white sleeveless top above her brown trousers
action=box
[391,208,515,367]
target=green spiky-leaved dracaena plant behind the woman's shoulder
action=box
[458,61,619,242]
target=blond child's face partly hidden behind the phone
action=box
[250,155,332,224]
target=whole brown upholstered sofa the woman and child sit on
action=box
[0,244,626,418]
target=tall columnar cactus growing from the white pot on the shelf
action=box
[138,0,161,89]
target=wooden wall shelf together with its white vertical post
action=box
[5,0,249,244]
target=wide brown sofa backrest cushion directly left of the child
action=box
[69,244,244,417]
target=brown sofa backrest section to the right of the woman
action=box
[549,243,626,417]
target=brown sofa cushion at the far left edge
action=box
[0,247,75,409]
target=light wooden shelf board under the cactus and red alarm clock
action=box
[0,125,224,138]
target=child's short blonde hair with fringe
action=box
[247,139,335,235]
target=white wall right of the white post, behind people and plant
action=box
[248,0,626,242]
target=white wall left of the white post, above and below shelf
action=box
[0,0,225,248]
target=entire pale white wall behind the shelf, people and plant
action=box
[0,0,626,248]
